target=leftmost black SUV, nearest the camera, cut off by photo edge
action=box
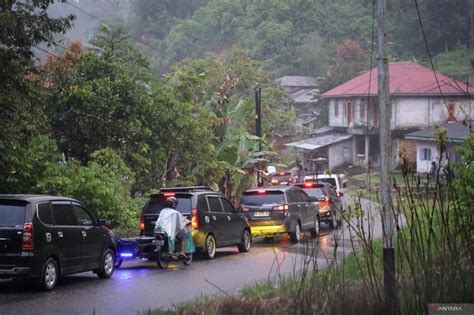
[0,195,116,290]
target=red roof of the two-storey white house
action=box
[322,62,474,98]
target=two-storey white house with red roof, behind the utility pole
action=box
[286,62,474,170]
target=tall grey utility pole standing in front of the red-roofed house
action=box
[377,0,398,314]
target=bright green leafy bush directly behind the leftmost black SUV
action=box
[38,148,140,227]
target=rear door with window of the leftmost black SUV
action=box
[0,199,28,268]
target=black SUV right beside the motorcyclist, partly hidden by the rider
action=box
[140,186,252,259]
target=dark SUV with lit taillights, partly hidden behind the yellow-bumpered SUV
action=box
[295,181,343,229]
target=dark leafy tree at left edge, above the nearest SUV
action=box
[0,0,72,193]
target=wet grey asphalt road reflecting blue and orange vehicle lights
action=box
[0,199,381,315]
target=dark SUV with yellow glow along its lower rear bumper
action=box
[240,186,319,242]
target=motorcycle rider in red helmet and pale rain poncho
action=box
[155,196,191,257]
